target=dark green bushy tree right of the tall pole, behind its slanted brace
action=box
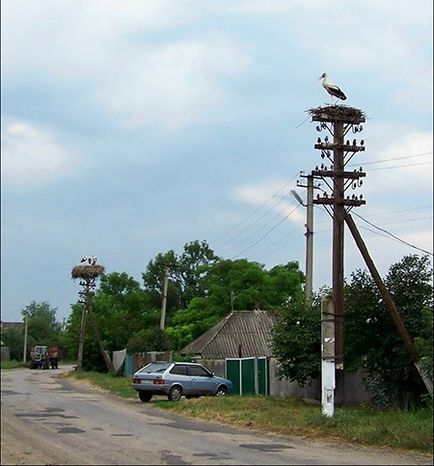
[345,255,433,409]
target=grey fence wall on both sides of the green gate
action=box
[195,358,371,406]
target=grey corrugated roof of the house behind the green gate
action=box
[181,310,276,359]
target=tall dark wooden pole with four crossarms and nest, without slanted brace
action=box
[310,105,365,369]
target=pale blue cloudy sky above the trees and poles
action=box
[1,0,433,321]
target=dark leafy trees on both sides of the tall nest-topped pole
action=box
[273,255,433,407]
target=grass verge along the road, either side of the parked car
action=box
[67,372,433,453]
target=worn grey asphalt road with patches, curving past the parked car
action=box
[1,367,432,465]
